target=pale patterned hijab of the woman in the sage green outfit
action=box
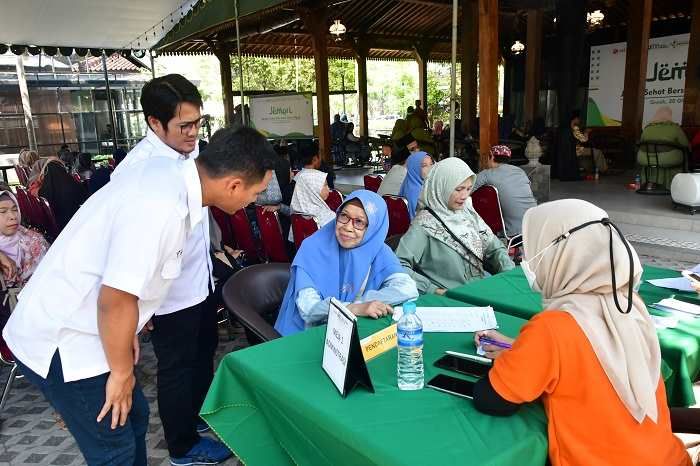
[414,157,484,269]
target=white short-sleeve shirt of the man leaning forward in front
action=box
[3,157,202,382]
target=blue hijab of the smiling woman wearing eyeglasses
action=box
[275,190,403,336]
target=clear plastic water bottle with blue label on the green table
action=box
[396,301,423,390]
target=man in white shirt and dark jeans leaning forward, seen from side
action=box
[3,124,275,465]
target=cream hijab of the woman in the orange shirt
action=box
[523,199,661,423]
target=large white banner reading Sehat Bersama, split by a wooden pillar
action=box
[586,34,690,126]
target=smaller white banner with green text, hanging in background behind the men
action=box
[250,94,314,139]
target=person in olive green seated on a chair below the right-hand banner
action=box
[637,106,690,189]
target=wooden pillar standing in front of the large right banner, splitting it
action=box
[622,0,652,151]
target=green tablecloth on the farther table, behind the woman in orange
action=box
[447,266,700,407]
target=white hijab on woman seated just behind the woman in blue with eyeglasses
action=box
[289,168,335,241]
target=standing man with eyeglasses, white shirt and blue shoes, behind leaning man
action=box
[112,74,231,465]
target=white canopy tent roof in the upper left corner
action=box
[0,0,198,49]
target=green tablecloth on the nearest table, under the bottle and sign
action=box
[201,296,547,466]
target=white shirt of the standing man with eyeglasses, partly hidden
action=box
[112,129,214,315]
